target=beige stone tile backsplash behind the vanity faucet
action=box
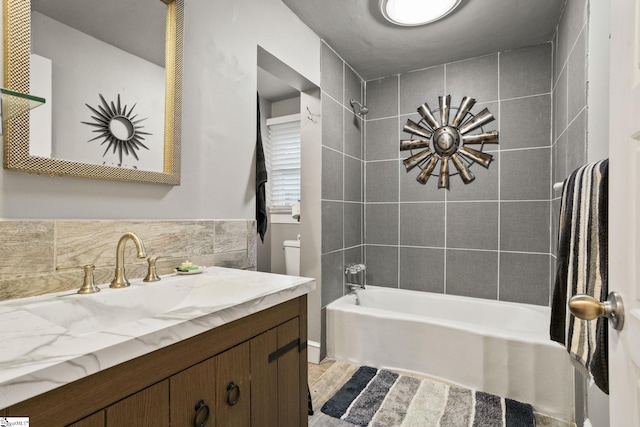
[0,220,256,300]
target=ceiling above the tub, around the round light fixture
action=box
[282,0,566,80]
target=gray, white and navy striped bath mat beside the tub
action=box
[321,366,535,427]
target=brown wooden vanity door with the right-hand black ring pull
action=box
[215,341,251,427]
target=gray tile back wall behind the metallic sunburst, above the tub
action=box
[364,43,556,305]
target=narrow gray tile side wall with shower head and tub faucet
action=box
[320,43,364,320]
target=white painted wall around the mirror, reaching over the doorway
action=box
[0,0,320,219]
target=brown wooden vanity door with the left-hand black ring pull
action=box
[169,357,216,427]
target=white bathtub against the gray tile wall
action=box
[327,286,574,420]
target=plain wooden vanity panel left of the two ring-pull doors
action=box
[105,380,169,427]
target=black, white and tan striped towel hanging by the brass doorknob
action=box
[550,160,609,394]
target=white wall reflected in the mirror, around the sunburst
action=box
[31,11,165,172]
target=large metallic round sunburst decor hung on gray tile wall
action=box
[400,95,499,189]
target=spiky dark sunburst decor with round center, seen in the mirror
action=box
[82,94,151,165]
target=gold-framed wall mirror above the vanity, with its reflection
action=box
[4,0,184,185]
